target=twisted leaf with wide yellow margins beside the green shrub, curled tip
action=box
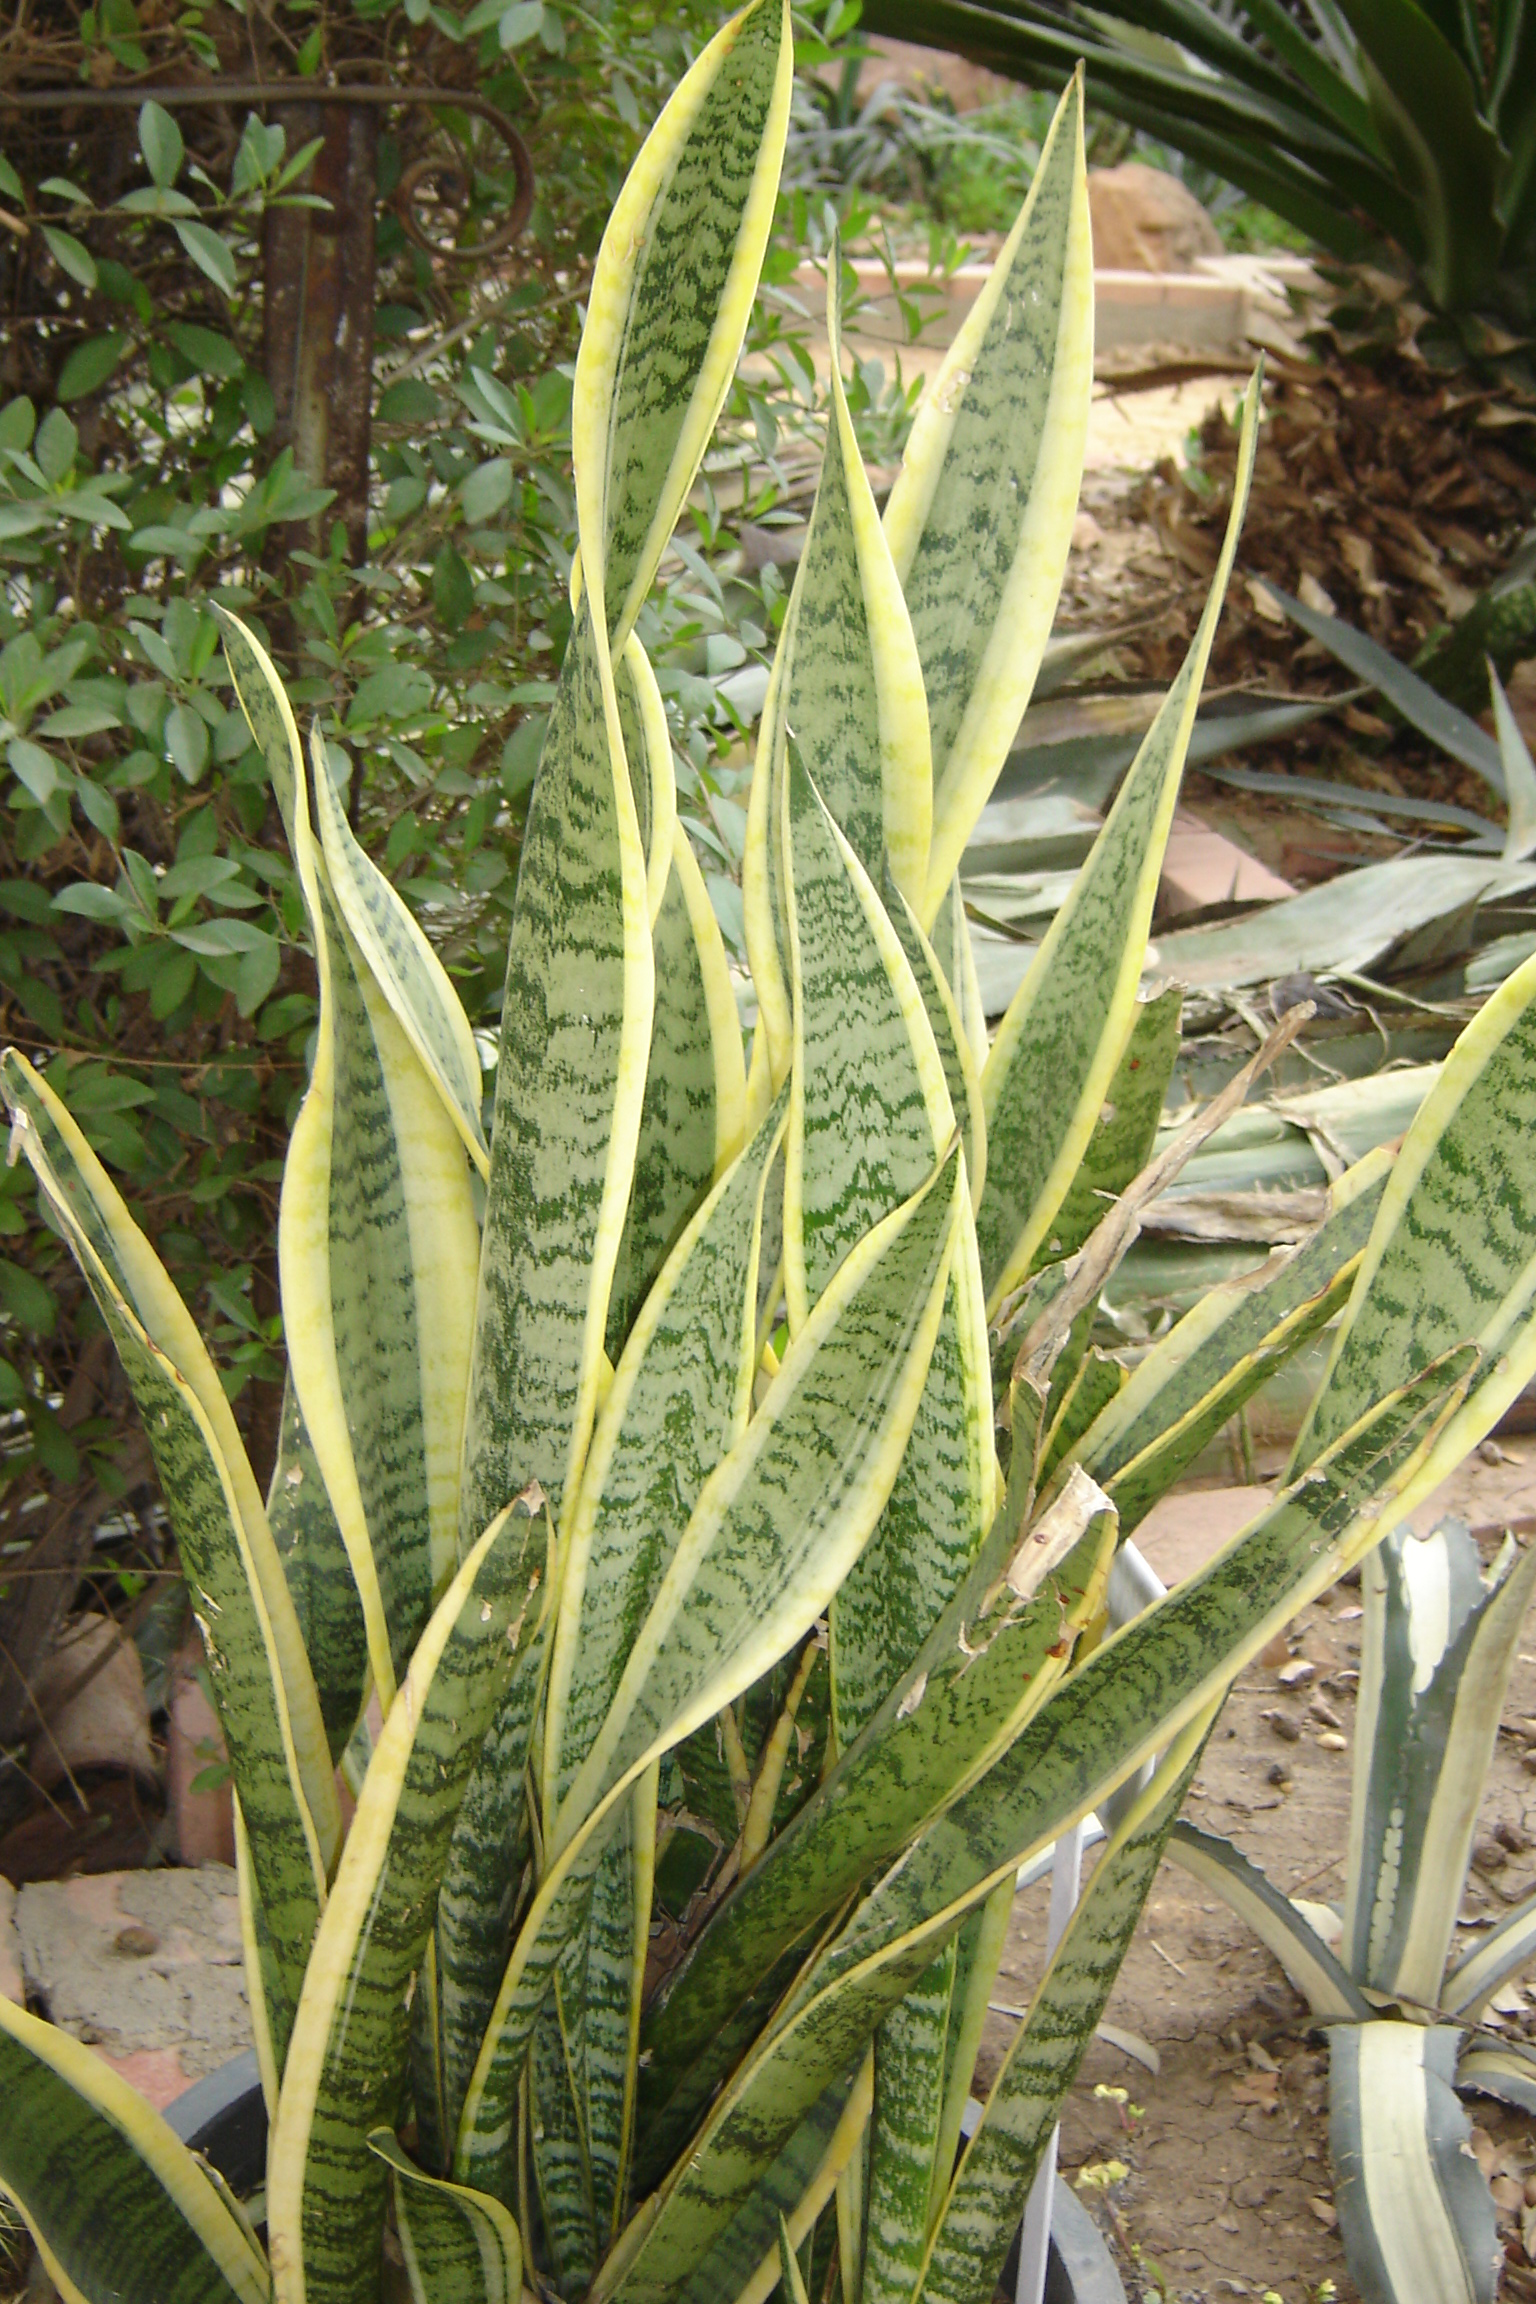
[223,617,479,1707]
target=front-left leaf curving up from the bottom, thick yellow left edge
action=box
[267,1505,546,2304]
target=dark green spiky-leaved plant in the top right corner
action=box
[864,0,1536,327]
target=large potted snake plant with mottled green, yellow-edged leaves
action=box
[0,0,1536,2304]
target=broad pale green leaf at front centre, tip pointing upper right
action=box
[550,1154,967,1848]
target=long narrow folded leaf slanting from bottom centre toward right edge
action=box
[612,1350,1473,2304]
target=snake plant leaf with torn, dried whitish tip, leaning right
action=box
[642,1479,1115,2168]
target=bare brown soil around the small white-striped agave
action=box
[979,1440,1536,2304]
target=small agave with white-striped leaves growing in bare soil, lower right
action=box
[1170,1511,1536,2304]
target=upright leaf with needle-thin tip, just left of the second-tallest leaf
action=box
[742,242,933,1083]
